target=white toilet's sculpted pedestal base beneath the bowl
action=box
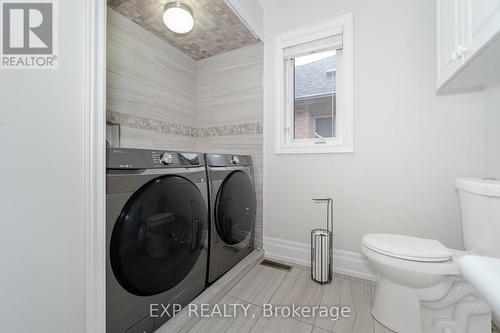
[372,276,491,333]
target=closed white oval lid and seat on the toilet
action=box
[362,234,453,262]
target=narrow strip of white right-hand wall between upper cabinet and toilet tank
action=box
[486,88,500,177]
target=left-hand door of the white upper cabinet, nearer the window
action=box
[436,0,462,88]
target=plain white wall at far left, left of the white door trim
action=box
[0,0,84,333]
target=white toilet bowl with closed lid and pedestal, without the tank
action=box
[361,234,491,333]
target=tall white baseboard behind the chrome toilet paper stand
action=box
[264,237,377,281]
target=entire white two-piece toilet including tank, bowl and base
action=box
[361,178,500,333]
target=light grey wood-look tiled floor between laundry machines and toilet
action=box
[157,251,500,333]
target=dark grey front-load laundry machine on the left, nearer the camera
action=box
[106,148,208,333]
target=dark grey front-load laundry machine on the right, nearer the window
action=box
[205,154,256,283]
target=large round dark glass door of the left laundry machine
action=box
[110,176,208,296]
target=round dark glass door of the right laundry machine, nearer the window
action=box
[215,171,256,245]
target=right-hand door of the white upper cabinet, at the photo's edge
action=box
[461,0,500,62]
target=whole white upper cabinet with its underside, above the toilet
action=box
[436,0,500,91]
